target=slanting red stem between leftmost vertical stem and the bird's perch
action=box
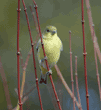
[22,0,43,110]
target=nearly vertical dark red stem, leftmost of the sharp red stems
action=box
[17,0,22,110]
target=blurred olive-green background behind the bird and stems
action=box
[0,0,101,110]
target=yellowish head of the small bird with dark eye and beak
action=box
[43,26,57,38]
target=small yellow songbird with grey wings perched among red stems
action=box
[36,26,63,84]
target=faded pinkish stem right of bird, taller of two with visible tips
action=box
[69,31,75,110]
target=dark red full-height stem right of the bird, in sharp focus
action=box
[81,0,89,110]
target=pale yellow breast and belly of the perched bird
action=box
[39,37,60,64]
